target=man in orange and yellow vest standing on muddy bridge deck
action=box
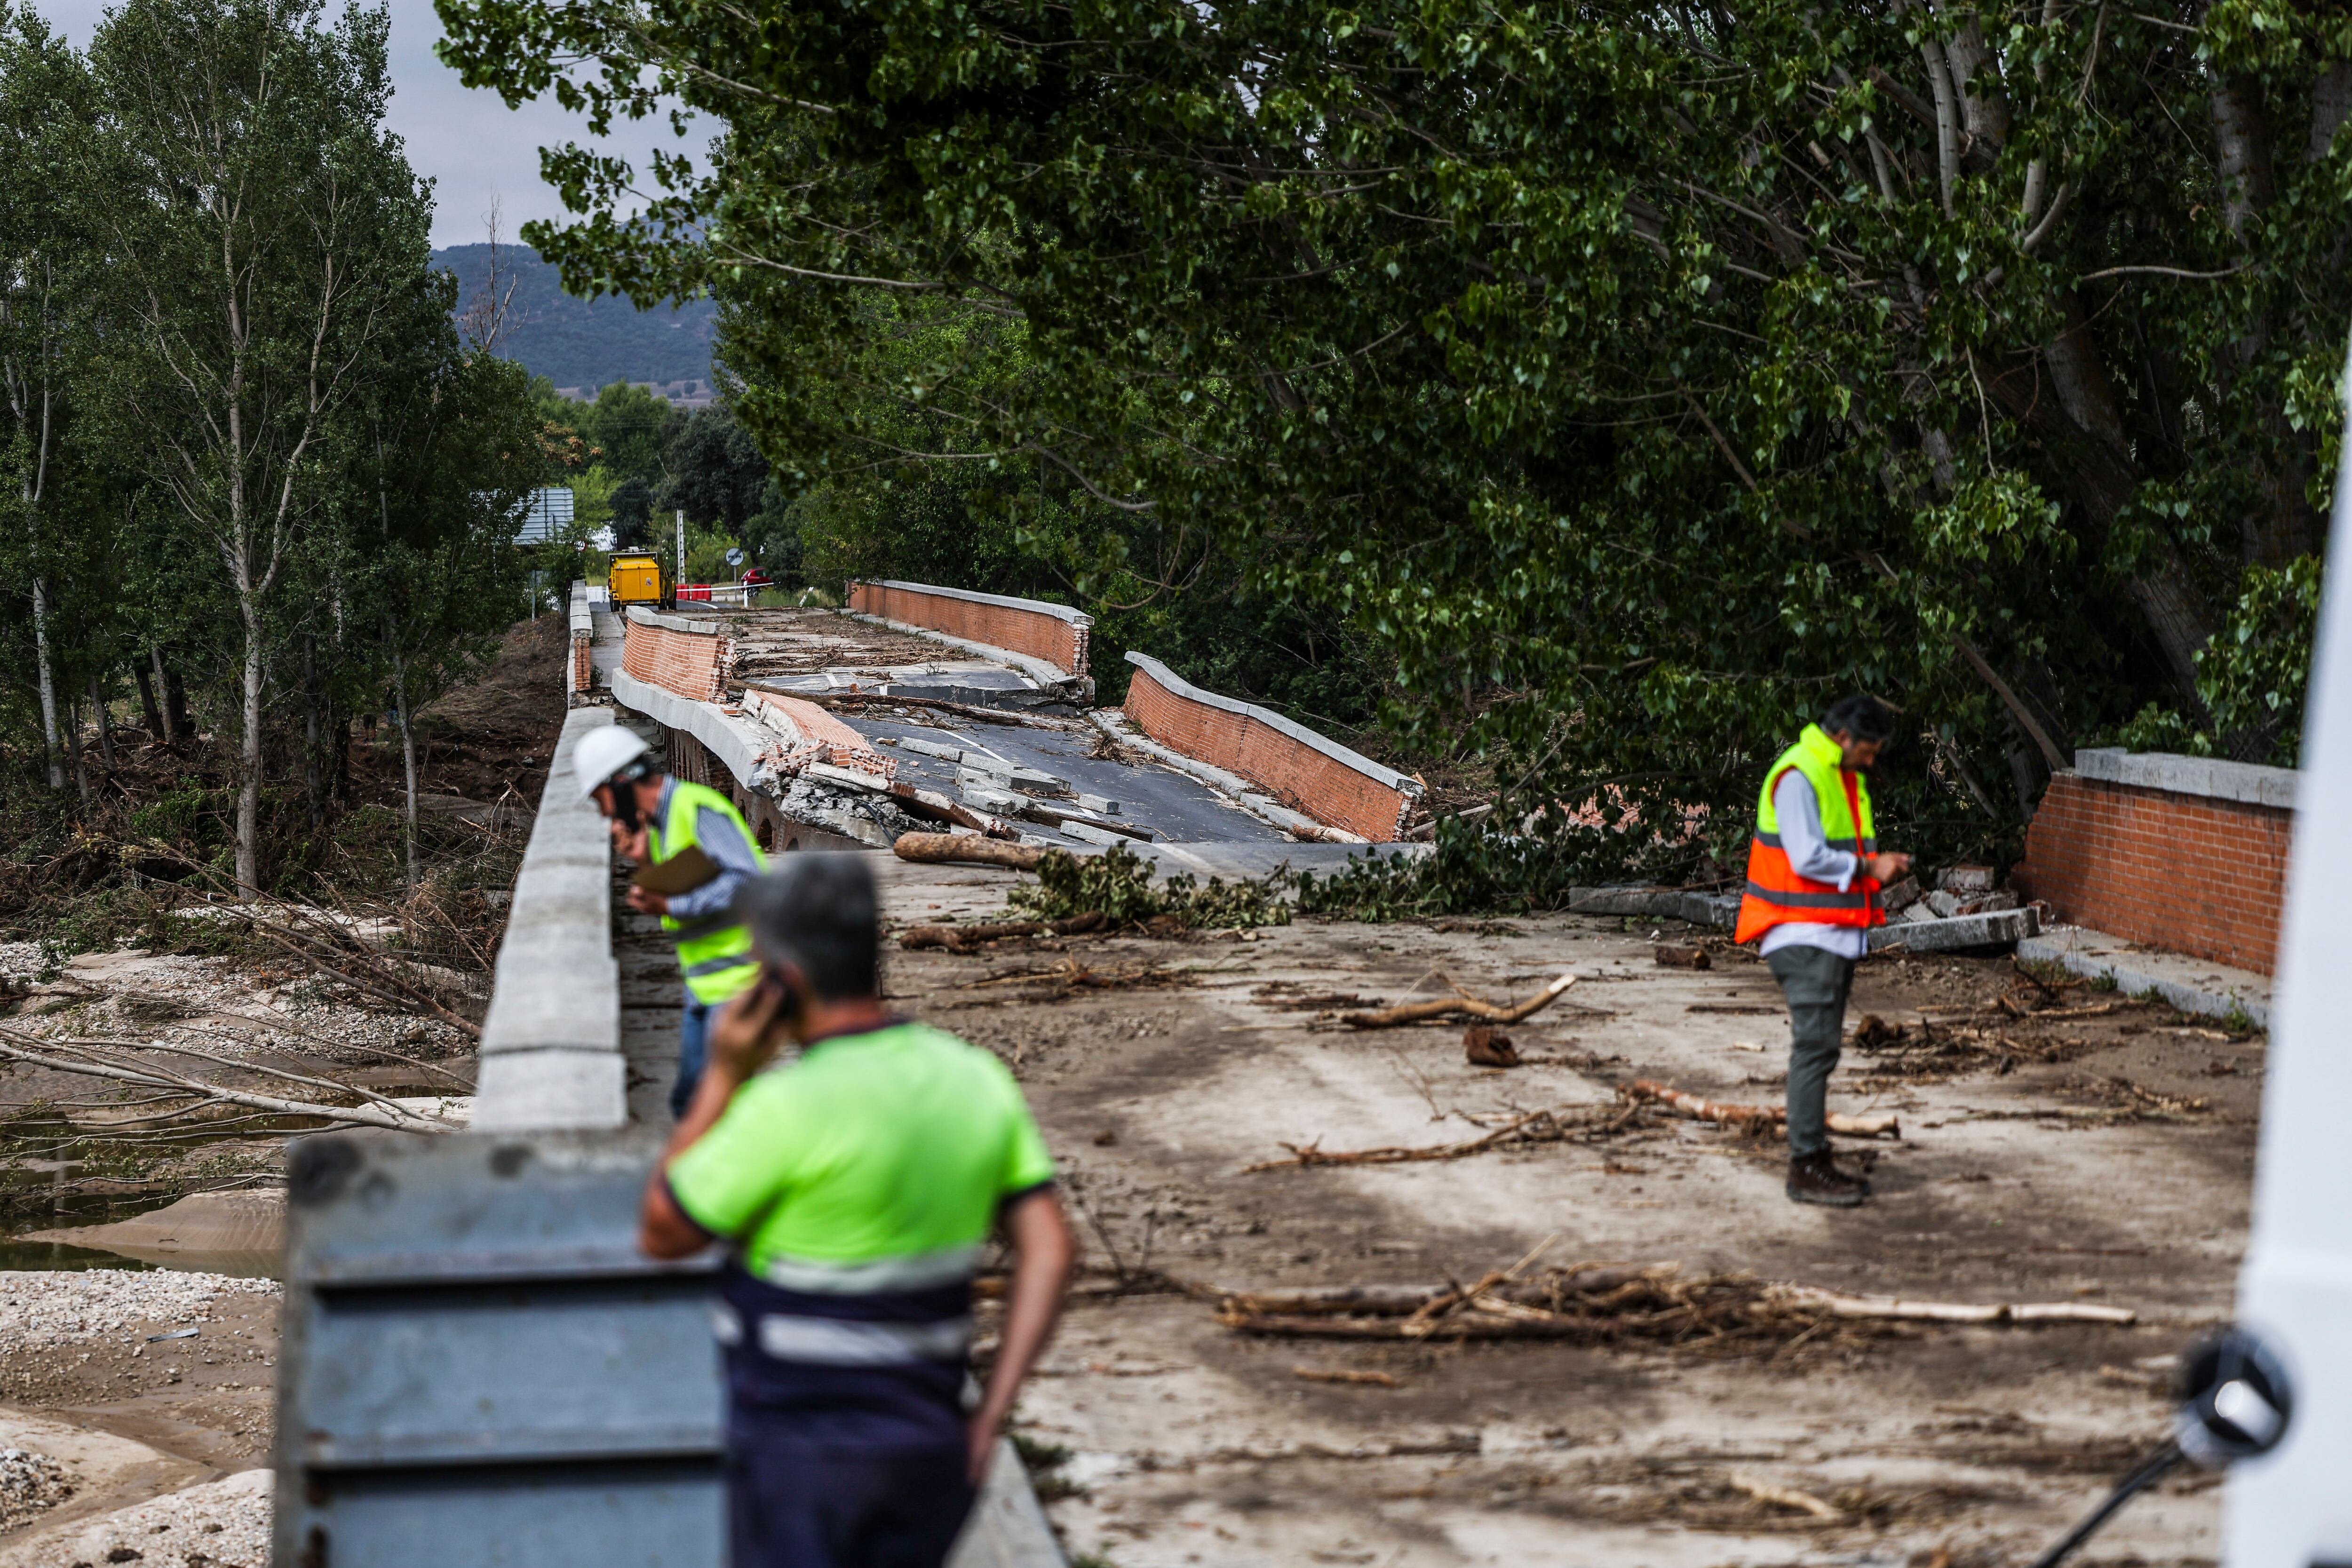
[1733,696,1910,1208]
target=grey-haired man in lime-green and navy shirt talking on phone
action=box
[640,853,1075,1568]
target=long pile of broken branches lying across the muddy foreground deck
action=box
[1216,1262,2133,1356]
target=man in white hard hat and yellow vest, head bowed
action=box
[572,724,767,1117]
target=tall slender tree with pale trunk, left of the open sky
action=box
[80,0,430,889]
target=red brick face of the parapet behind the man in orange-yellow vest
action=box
[2013,773,2296,973]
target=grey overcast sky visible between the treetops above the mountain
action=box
[38,0,701,245]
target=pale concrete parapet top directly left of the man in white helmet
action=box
[473,708,628,1131]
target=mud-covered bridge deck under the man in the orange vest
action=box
[891,863,2263,1568]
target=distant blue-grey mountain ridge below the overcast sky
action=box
[433,245,717,397]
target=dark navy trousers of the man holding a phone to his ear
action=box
[727,1406,974,1568]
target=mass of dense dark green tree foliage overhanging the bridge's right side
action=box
[440,0,2352,875]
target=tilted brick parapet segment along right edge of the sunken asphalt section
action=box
[1127,656,1414,844]
